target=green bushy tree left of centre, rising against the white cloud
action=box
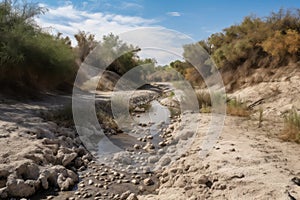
[84,32,146,75]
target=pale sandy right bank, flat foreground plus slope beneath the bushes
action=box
[139,76,300,200]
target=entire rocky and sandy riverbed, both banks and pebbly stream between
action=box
[0,76,300,200]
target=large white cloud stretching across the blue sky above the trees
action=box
[36,4,191,64]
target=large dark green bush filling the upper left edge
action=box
[0,1,75,92]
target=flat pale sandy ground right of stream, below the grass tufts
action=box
[139,115,300,200]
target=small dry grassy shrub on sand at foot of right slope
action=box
[226,98,251,117]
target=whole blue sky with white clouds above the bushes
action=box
[33,0,300,63]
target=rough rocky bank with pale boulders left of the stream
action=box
[0,96,92,199]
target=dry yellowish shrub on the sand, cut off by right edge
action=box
[281,109,300,143]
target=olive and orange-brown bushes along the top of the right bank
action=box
[173,9,300,88]
